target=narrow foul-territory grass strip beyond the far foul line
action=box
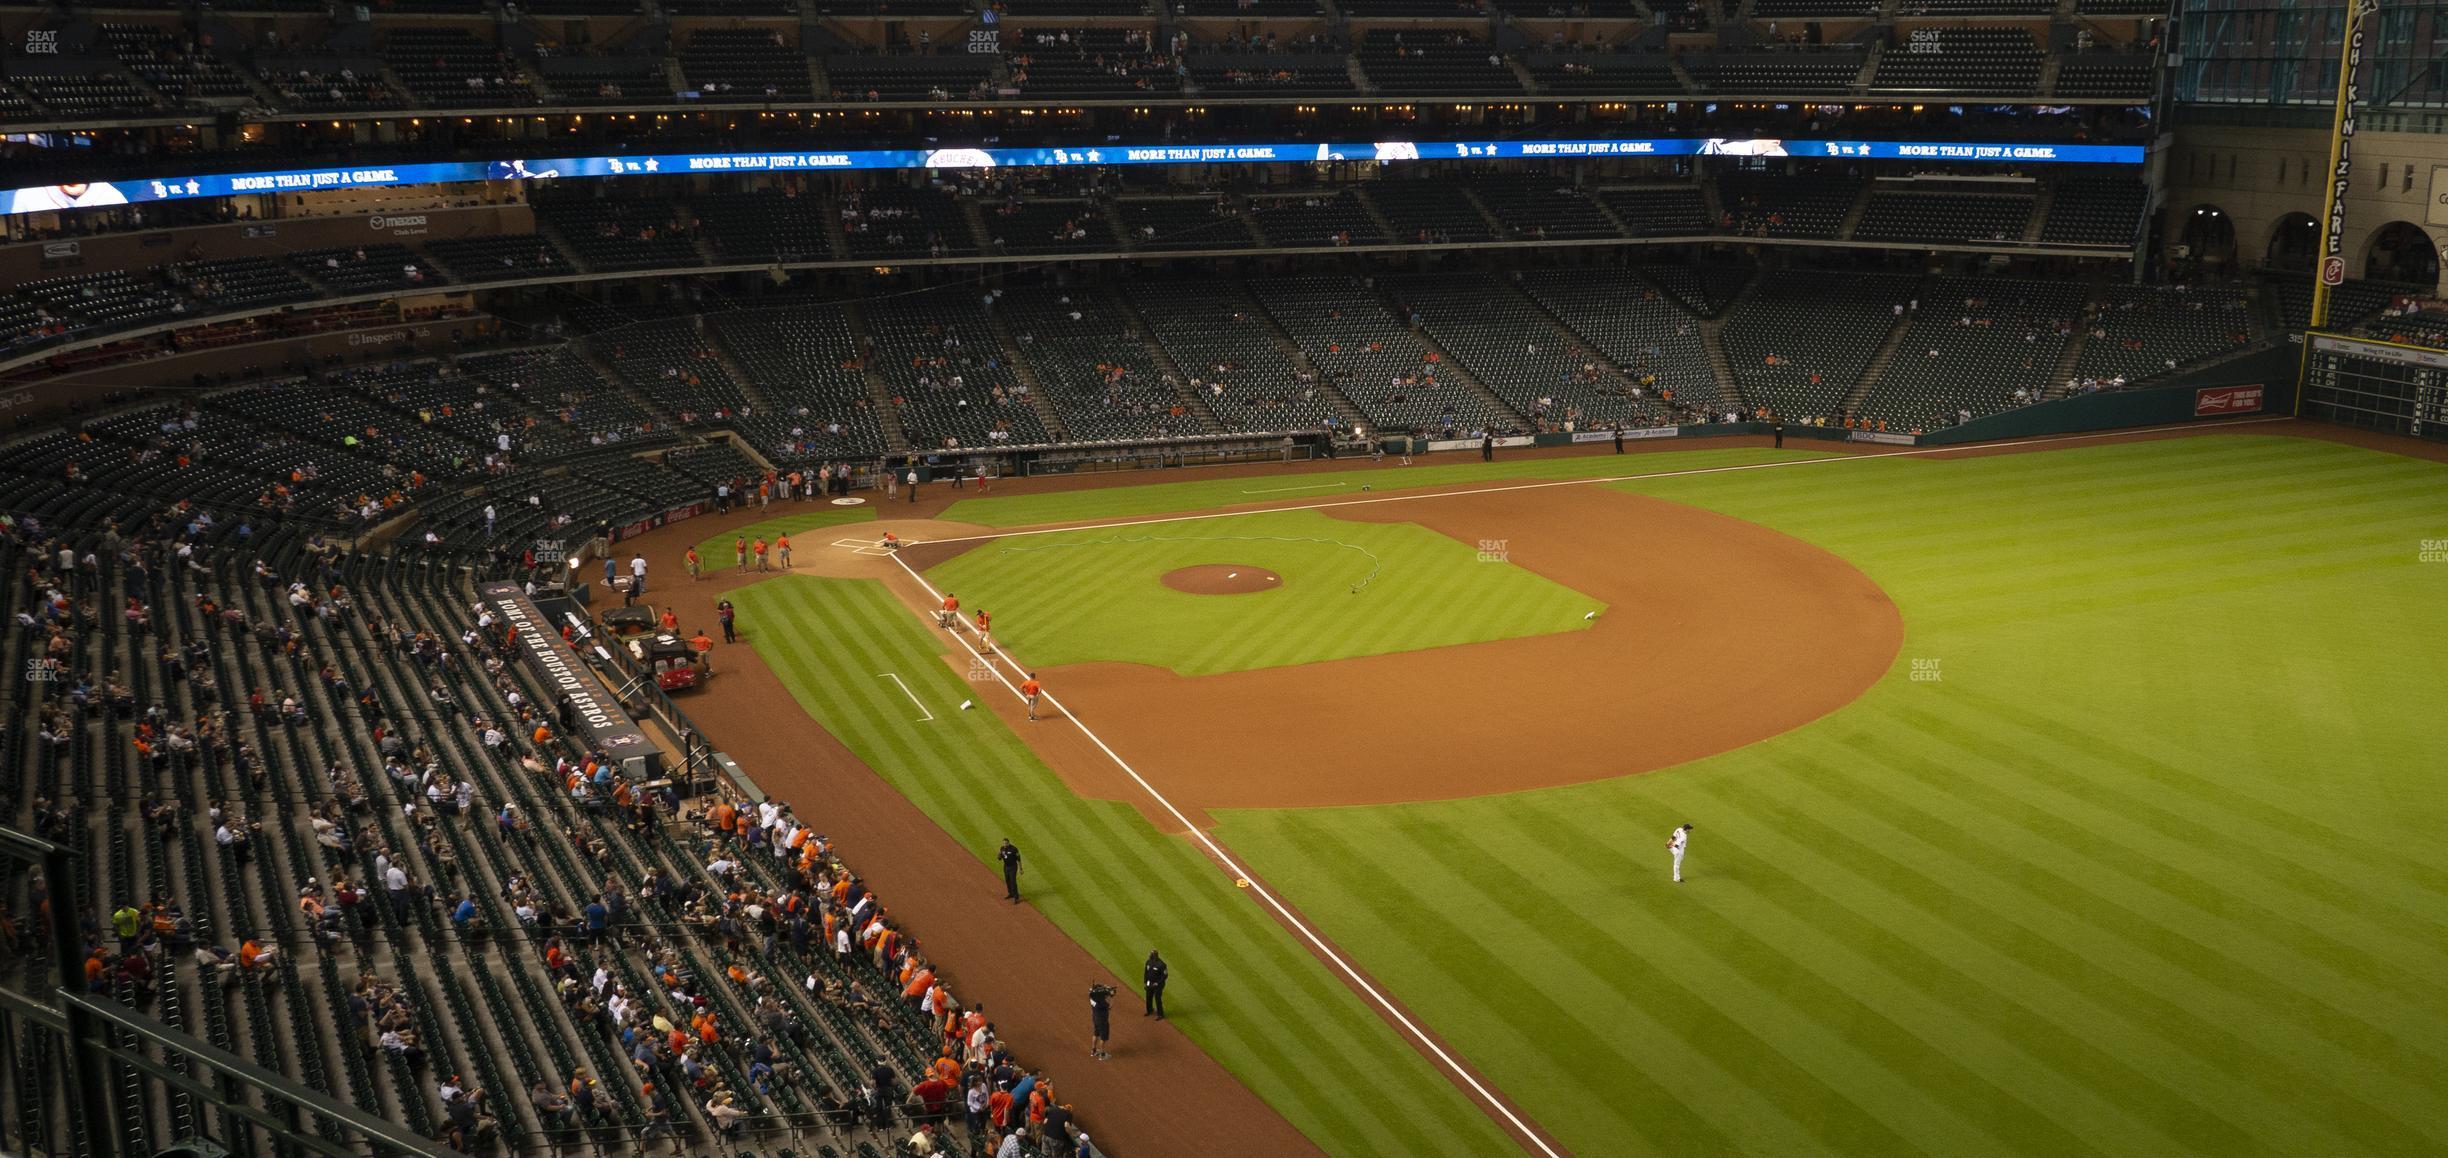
[935,448,1836,526]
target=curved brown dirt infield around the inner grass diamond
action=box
[984,487,1905,827]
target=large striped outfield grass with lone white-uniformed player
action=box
[1224,436,2448,1156]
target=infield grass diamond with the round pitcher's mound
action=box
[928,512,1606,676]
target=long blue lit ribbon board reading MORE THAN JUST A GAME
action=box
[0,137,2142,213]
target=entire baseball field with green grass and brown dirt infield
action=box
[668,428,2448,1158]
